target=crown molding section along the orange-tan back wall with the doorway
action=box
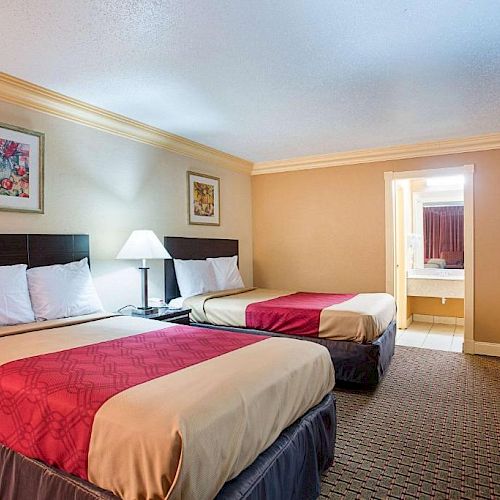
[252,133,500,175]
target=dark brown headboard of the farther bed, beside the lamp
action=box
[163,236,238,302]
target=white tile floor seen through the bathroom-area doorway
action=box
[396,322,464,352]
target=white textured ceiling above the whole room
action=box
[0,0,500,161]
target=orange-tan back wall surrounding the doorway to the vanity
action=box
[252,150,500,342]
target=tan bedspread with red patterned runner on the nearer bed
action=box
[0,315,334,500]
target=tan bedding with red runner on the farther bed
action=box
[183,288,396,343]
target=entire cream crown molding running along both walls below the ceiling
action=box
[0,72,500,175]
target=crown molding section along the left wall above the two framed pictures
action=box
[0,72,253,174]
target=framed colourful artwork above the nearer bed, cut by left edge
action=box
[0,123,45,213]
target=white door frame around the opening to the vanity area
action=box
[384,165,474,354]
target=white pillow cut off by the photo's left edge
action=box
[0,264,35,326]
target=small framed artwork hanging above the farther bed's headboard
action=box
[187,172,220,226]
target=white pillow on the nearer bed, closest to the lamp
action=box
[27,258,103,320]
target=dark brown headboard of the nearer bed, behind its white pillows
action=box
[0,234,90,267]
